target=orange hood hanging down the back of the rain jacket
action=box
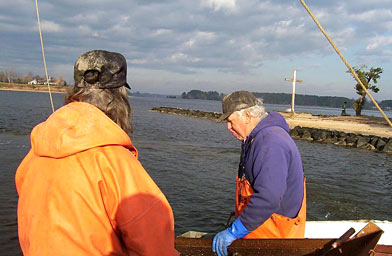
[31,102,137,158]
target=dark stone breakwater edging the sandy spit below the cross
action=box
[151,107,392,154]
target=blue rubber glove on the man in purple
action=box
[212,218,250,256]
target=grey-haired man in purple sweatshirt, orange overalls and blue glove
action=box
[212,91,306,256]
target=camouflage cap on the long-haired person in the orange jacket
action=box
[74,50,131,89]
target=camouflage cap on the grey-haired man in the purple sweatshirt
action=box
[218,91,259,122]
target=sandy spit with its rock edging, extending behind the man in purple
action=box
[150,107,392,154]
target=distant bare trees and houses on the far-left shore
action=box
[0,69,67,86]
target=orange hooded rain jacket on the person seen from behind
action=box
[15,102,178,256]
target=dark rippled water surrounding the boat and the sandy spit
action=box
[0,91,392,255]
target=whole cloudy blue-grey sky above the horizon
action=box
[0,0,392,100]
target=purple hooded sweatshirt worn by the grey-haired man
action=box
[238,112,304,231]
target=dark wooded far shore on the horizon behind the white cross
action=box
[181,90,392,110]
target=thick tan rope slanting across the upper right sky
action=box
[299,0,392,131]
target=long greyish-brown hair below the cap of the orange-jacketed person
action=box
[65,86,133,133]
